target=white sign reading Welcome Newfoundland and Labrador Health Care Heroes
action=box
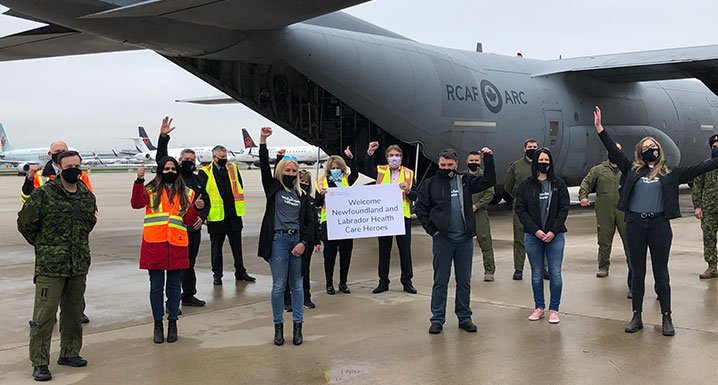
[326,183,405,240]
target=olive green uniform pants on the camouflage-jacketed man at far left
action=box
[30,275,87,366]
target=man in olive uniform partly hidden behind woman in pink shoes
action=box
[504,139,548,281]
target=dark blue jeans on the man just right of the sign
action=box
[431,234,474,325]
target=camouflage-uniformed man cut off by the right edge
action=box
[692,135,718,279]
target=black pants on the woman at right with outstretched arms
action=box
[626,212,673,313]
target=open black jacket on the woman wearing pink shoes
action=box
[514,177,571,235]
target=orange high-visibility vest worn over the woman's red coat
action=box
[142,187,194,246]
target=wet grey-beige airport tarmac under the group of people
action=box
[0,170,718,385]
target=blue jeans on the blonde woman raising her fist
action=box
[269,233,304,323]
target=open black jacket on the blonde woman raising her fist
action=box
[257,144,316,261]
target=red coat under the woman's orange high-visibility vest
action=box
[130,183,198,270]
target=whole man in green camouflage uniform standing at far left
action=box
[17,151,97,381]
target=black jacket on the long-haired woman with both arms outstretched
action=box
[598,130,718,219]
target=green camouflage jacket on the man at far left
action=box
[17,179,97,277]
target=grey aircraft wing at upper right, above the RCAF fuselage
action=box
[533,45,718,92]
